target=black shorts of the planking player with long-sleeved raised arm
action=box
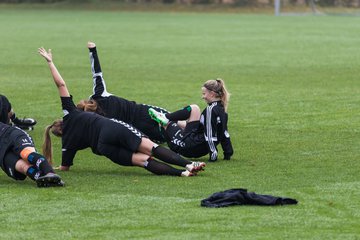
[133,104,168,143]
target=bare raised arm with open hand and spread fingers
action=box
[38,47,70,97]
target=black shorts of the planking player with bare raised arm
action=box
[97,119,143,166]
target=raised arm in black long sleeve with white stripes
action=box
[88,42,111,97]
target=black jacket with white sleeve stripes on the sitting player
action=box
[200,101,234,160]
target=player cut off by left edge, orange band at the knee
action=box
[0,98,64,187]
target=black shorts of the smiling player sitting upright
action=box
[166,121,209,158]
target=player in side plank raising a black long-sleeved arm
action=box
[77,42,168,143]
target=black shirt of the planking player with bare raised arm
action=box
[61,97,106,166]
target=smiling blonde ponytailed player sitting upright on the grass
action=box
[149,79,233,162]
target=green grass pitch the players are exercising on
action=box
[0,5,360,240]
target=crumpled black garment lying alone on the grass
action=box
[201,188,298,208]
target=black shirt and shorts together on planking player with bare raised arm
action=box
[61,97,142,166]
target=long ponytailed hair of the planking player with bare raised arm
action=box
[42,119,63,164]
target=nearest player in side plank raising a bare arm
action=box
[39,48,205,176]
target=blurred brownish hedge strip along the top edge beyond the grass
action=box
[0,0,360,8]
